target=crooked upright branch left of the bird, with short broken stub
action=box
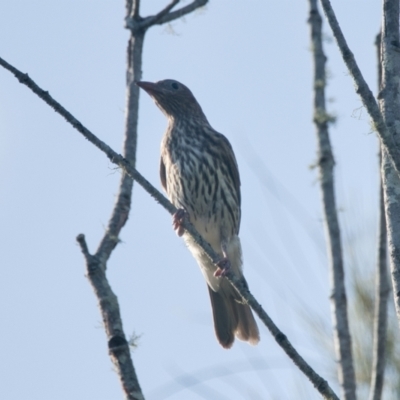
[67,0,144,400]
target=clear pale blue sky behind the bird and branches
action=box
[0,0,381,400]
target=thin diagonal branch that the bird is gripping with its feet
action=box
[0,58,339,400]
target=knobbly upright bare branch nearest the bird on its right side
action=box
[308,0,356,400]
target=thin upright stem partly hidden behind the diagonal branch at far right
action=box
[369,34,390,400]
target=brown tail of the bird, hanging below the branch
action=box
[208,282,260,349]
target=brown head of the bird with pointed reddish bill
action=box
[136,79,206,119]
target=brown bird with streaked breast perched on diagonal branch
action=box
[137,79,260,349]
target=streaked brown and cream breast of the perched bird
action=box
[163,135,240,241]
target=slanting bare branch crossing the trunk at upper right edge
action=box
[321,0,400,179]
